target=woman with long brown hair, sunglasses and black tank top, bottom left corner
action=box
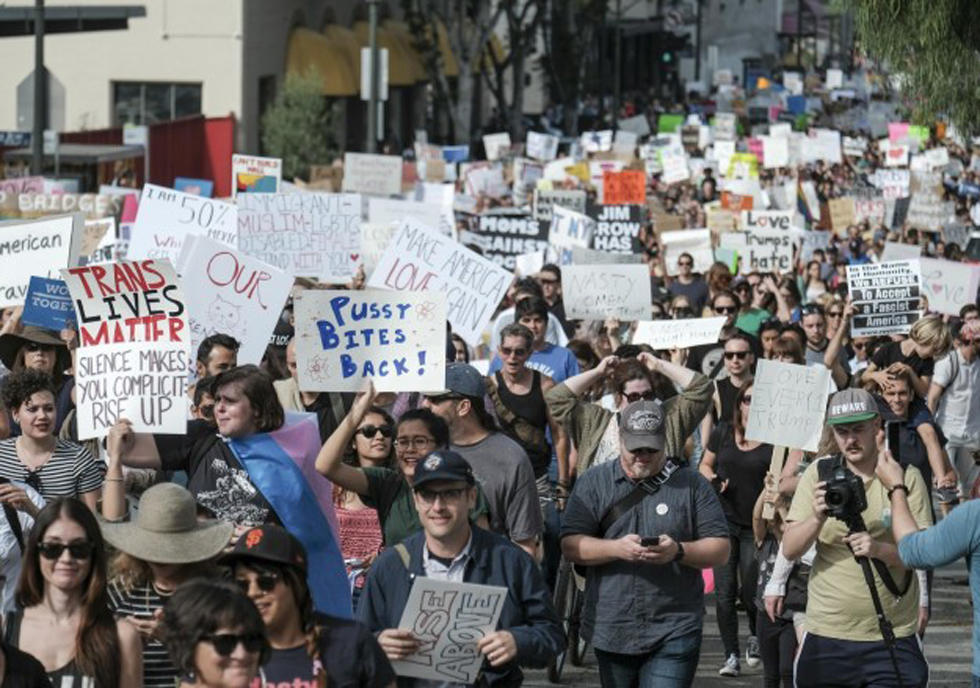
[4,498,143,688]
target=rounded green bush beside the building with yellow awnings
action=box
[262,71,337,179]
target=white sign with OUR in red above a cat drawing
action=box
[177,237,293,365]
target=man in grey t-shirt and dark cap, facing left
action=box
[422,363,544,558]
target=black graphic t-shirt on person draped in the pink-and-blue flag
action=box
[154,420,279,526]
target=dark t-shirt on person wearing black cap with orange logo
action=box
[253,614,395,688]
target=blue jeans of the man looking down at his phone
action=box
[595,629,701,688]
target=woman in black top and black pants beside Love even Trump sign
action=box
[698,380,802,676]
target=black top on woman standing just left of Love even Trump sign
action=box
[707,422,772,528]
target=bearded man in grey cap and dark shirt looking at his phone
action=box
[561,400,729,688]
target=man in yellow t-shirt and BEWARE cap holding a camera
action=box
[783,389,931,688]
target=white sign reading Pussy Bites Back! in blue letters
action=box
[295,289,446,392]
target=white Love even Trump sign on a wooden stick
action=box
[745,358,830,452]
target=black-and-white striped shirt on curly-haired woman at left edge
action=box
[0,437,106,501]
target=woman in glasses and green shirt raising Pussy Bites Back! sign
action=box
[316,381,489,547]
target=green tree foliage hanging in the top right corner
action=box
[841,0,980,136]
